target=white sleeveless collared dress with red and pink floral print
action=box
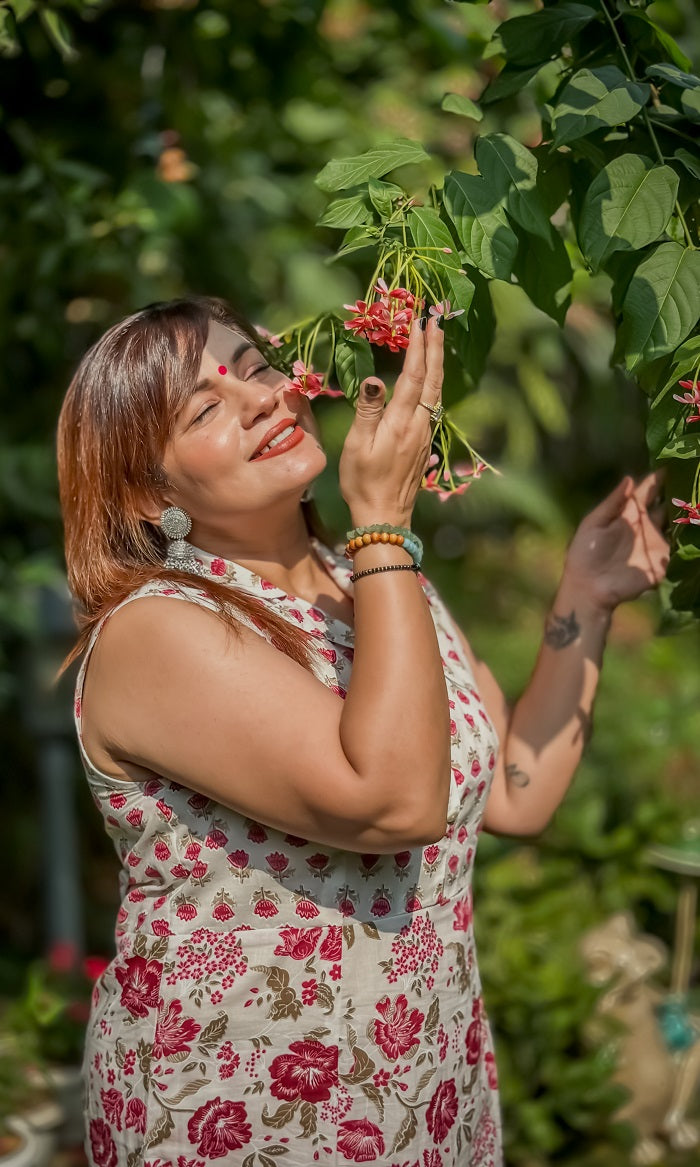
[75,540,503,1167]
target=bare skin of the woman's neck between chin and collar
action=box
[189,503,323,594]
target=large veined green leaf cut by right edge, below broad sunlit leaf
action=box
[620,243,700,371]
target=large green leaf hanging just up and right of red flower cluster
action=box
[443,170,518,282]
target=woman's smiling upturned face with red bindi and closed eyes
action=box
[158,321,326,541]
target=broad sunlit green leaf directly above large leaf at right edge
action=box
[578,154,678,271]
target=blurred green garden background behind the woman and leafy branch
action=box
[0,0,700,1167]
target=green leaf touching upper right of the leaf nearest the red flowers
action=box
[475,134,550,240]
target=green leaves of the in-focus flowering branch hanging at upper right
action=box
[298,0,700,614]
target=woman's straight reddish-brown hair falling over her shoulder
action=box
[57,296,326,668]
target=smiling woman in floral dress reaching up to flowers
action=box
[58,300,667,1167]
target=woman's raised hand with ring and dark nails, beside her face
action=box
[340,317,445,526]
